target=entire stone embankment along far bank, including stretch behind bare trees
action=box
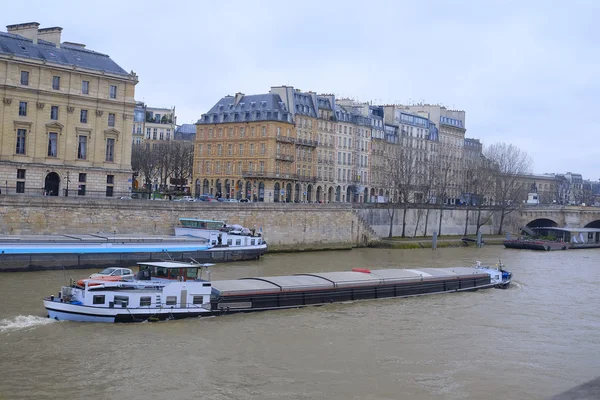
[0,195,512,251]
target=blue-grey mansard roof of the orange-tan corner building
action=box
[197,93,293,124]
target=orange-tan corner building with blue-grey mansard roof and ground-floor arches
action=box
[193,93,298,202]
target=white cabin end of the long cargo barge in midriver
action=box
[44,261,213,322]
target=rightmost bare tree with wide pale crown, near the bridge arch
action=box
[484,143,532,235]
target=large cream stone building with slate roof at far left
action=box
[0,22,138,197]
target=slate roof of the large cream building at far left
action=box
[0,32,129,75]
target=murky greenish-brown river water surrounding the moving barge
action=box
[0,246,600,400]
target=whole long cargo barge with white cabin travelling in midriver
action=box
[44,261,512,322]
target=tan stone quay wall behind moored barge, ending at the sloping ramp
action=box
[0,195,377,251]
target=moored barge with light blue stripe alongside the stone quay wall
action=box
[0,228,267,272]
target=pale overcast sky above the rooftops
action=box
[0,0,600,180]
